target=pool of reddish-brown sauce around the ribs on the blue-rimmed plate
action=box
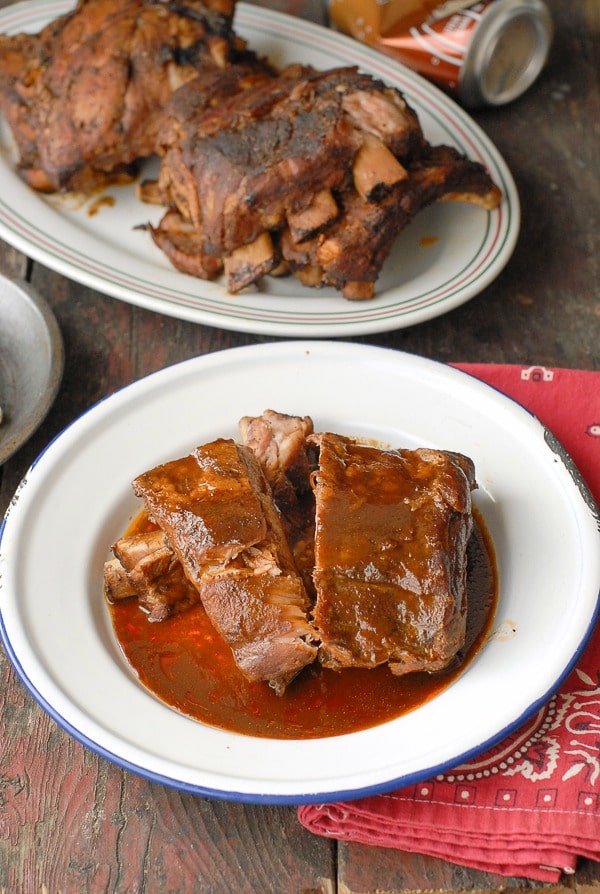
[109,513,498,739]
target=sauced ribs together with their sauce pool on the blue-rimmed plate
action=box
[105,410,497,738]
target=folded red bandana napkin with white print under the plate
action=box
[298,364,600,882]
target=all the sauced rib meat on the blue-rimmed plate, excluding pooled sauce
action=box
[105,410,477,694]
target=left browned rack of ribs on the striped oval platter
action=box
[0,0,245,192]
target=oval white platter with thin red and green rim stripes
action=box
[0,0,520,338]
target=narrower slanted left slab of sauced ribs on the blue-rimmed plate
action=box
[133,439,317,693]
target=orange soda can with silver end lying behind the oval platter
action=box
[329,0,553,107]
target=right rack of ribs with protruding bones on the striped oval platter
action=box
[149,64,501,299]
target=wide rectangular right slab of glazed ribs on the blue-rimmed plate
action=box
[313,433,476,675]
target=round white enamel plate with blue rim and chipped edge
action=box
[0,340,600,803]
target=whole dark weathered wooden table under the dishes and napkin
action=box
[0,0,600,894]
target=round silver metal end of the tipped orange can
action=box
[460,0,553,106]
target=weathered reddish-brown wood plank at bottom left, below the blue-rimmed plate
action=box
[0,657,334,894]
